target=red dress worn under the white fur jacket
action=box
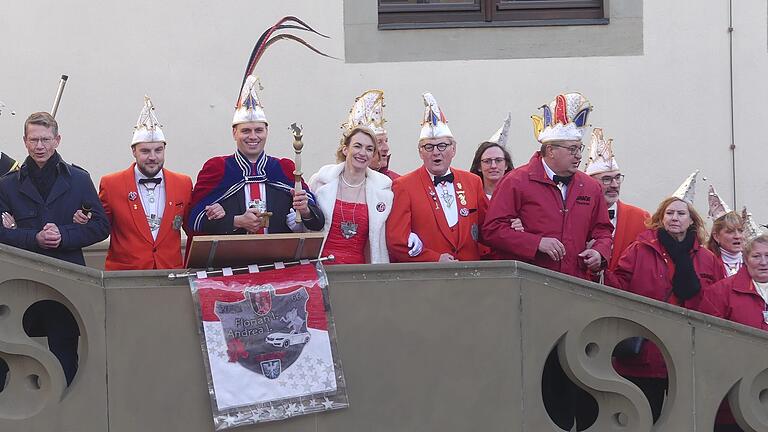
[323,199,368,264]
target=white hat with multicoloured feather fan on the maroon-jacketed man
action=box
[531,93,592,144]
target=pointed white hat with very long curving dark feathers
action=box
[232,16,331,126]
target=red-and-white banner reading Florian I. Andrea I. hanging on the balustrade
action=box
[190,265,347,430]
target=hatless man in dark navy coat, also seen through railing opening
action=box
[0,112,109,384]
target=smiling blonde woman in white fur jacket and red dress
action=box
[309,126,393,264]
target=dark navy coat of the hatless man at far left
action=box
[0,157,109,265]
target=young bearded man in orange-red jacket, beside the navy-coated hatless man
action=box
[99,97,192,270]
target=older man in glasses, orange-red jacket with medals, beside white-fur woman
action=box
[387,93,488,262]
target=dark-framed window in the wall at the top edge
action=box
[378,0,608,29]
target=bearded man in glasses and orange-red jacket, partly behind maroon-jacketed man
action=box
[584,128,651,270]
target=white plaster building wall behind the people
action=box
[0,0,768,222]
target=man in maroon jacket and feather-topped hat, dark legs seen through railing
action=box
[483,93,613,430]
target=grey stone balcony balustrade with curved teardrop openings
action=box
[0,245,768,432]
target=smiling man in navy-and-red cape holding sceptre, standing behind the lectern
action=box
[194,76,325,234]
